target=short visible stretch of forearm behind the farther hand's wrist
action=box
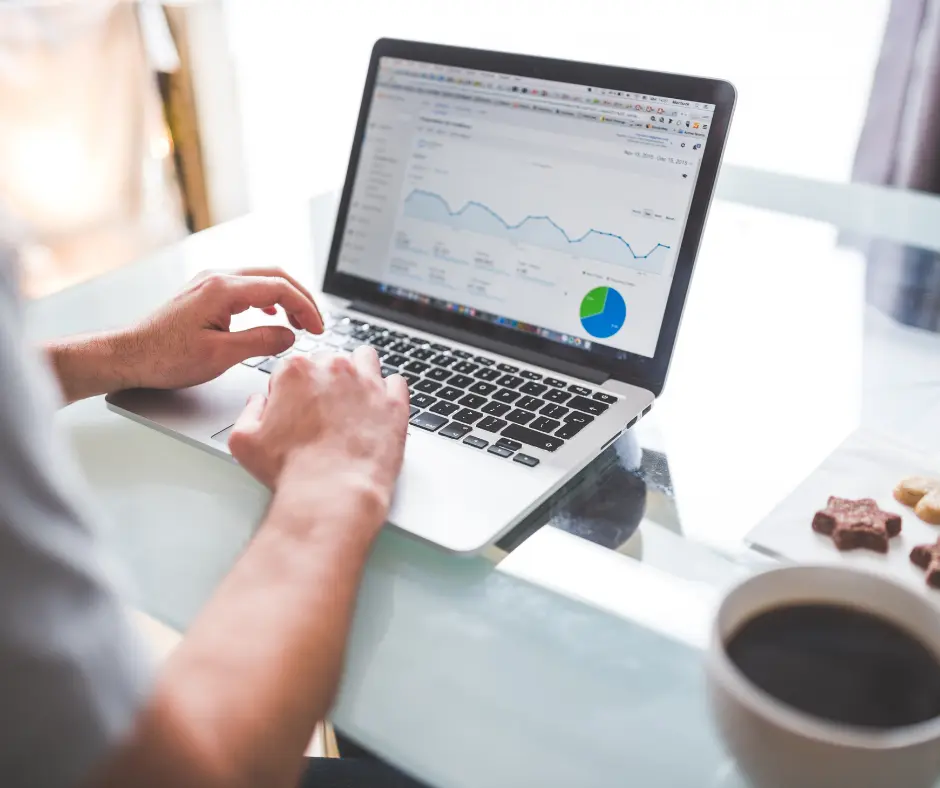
[45,331,135,403]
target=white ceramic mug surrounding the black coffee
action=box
[707,566,940,788]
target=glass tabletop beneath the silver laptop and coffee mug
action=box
[29,188,940,788]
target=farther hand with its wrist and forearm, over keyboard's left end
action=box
[48,268,323,402]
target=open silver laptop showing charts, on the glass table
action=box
[108,40,735,554]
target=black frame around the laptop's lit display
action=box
[323,39,735,396]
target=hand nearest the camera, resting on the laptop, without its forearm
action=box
[229,347,409,529]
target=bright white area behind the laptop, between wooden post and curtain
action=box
[227,0,889,207]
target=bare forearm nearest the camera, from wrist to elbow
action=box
[88,464,376,787]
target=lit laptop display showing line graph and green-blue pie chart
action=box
[337,57,715,358]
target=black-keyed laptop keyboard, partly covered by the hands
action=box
[242,314,618,468]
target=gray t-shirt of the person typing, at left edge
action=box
[0,239,151,788]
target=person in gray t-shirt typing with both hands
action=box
[0,247,426,788]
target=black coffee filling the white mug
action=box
[726,605,940,728]
